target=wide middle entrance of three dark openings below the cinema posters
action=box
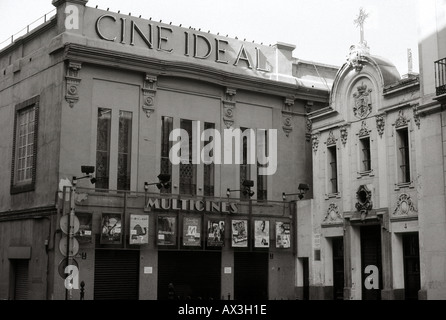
[158,251,221,300]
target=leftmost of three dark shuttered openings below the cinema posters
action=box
[94,250,139,300]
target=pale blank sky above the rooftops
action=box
[0,0,420,75]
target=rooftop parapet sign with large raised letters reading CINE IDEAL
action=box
[85,8,277,78]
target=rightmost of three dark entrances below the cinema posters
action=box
[234,252,269,300]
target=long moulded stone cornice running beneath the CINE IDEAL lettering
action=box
[60,43,328,101]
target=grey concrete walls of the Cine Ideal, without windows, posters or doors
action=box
[0,0,336,300]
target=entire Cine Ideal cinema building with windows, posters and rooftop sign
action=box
[0,0,338,300]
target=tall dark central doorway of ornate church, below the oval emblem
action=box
[361,225,382,300]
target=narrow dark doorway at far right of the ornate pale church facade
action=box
[403,233,421,300]
